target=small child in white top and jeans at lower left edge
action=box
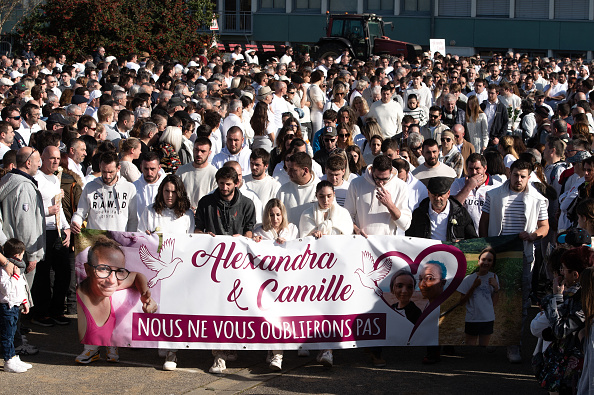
[0,239,33,373]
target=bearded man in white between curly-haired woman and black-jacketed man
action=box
[175,136,217,210]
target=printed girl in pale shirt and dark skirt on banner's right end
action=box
[458,248,499,347]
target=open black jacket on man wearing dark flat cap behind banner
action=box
[406,197,478,241]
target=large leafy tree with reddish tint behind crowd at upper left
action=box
[18,0,214,60]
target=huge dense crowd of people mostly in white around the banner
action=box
[0,41,594,393]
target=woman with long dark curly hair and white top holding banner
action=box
[138,174,194,371]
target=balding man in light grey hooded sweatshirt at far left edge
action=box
[0,147,45,288]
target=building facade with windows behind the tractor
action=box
[217,0,594,59]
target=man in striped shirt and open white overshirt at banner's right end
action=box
[479,160,549,363]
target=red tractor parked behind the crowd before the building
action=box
[312,14,422,61]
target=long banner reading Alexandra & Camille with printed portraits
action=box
[76,230,522,350]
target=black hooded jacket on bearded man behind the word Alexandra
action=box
[195,188,256,236]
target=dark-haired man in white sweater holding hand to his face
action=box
[344,155,411,237]
